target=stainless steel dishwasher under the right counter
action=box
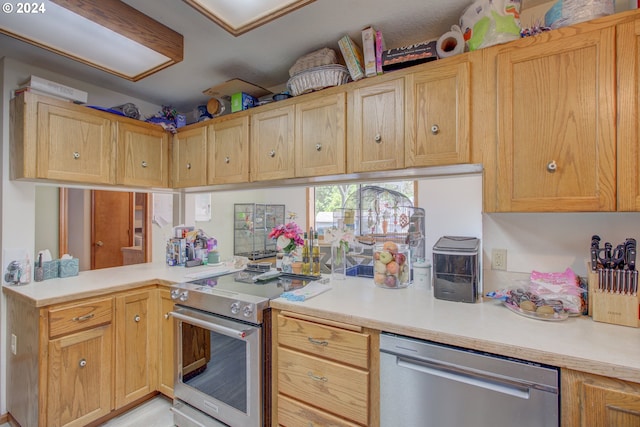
[380,333,560,427]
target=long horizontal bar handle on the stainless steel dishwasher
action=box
[396,356,530,399]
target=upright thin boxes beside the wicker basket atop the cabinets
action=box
[338,26,385,81]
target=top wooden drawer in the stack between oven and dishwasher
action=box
[278,315,369,369]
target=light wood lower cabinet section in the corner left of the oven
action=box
[6,285,173,427]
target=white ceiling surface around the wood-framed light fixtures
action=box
[0,0,472,111]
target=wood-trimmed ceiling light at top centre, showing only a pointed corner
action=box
[184,0,315,37]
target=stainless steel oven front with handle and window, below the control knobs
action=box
[172,307,265,427]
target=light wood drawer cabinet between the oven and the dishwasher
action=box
[273,311,380,427]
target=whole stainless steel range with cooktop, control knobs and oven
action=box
[171,270,317,427]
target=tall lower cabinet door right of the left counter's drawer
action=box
[115,290,157,408]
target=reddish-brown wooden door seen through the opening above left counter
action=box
[91,190,133,270]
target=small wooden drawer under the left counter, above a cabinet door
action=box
[49,297,113,338]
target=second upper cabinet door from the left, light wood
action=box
[116,122,169,187]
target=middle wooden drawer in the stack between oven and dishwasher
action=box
[278,347,369,425]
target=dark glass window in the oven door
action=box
[182,322,248,413]
